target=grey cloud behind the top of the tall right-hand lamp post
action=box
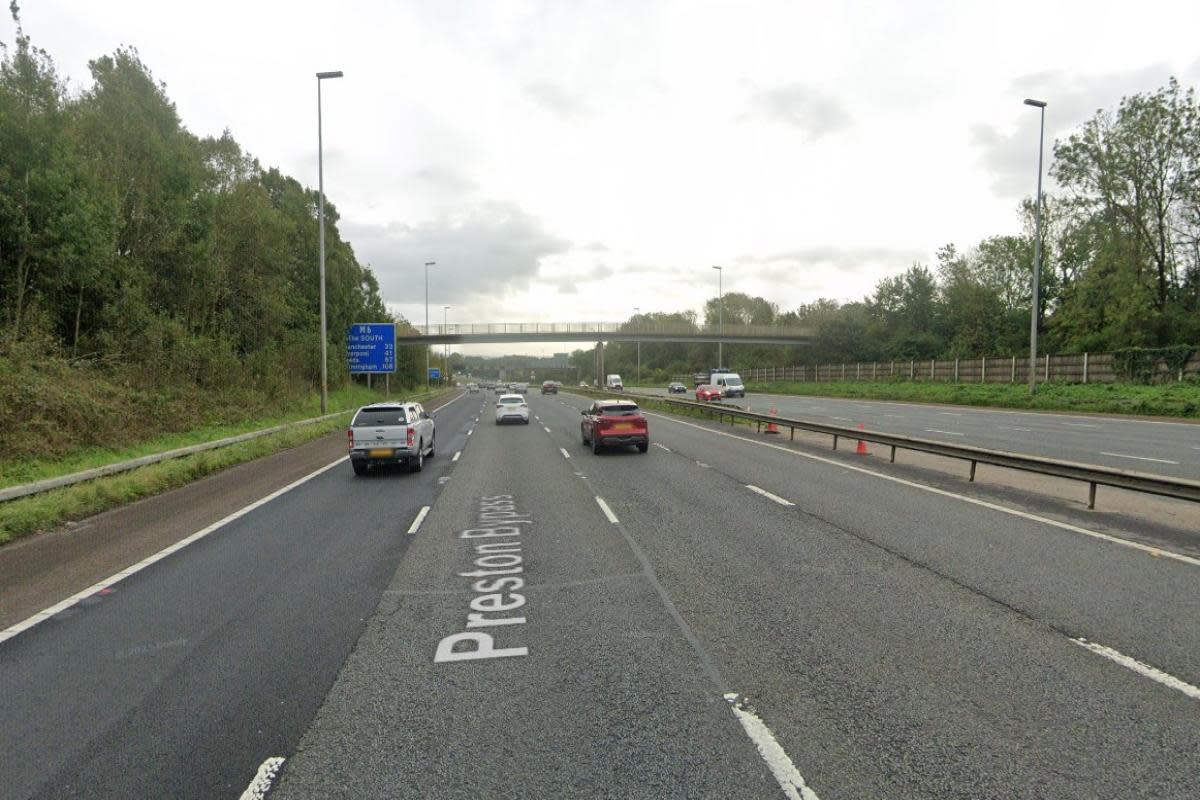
[971,62,1176,198]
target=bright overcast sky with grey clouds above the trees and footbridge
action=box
[9,0,1200,353]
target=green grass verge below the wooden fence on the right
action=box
[746,381,1200,419]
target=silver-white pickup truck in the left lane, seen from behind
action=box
[346,403,437,475]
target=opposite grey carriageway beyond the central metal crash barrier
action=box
[629,386,1200,480]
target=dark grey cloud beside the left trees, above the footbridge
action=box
[341,203,571,305]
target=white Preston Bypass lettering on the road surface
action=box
[433,494,533,663]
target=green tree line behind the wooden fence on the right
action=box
[590,78,1200,380]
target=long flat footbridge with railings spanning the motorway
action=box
[396,323,811,345]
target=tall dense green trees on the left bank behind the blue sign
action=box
[0,9,424,400]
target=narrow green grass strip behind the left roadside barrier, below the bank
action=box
[0,385,436,488]
